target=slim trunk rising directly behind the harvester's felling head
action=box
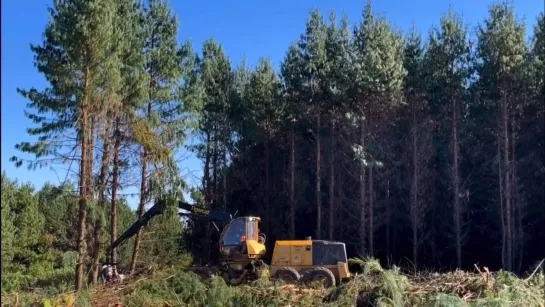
[110,118,121,268]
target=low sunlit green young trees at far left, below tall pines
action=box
[2,173,140,295]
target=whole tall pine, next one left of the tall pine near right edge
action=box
[424,9,471,268]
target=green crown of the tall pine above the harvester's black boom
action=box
[134,0,201,164]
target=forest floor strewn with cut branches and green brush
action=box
[2,260,545,307]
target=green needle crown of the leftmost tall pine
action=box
[11,0,118,168]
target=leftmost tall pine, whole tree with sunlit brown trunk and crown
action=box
[14,0,117,290]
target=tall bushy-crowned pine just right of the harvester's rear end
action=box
[356,2,405,255]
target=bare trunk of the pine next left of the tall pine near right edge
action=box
[452,99,462,269]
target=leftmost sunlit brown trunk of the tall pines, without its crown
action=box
[75,68,90,291]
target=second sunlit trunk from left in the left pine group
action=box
[91,119,110,284]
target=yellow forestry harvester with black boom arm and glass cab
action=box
[104,201,350,287]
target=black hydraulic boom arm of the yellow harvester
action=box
[106,200,233,255]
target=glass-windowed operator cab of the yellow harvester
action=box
[220,216,265,257]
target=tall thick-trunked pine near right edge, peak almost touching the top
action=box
[477,3,525,270]
